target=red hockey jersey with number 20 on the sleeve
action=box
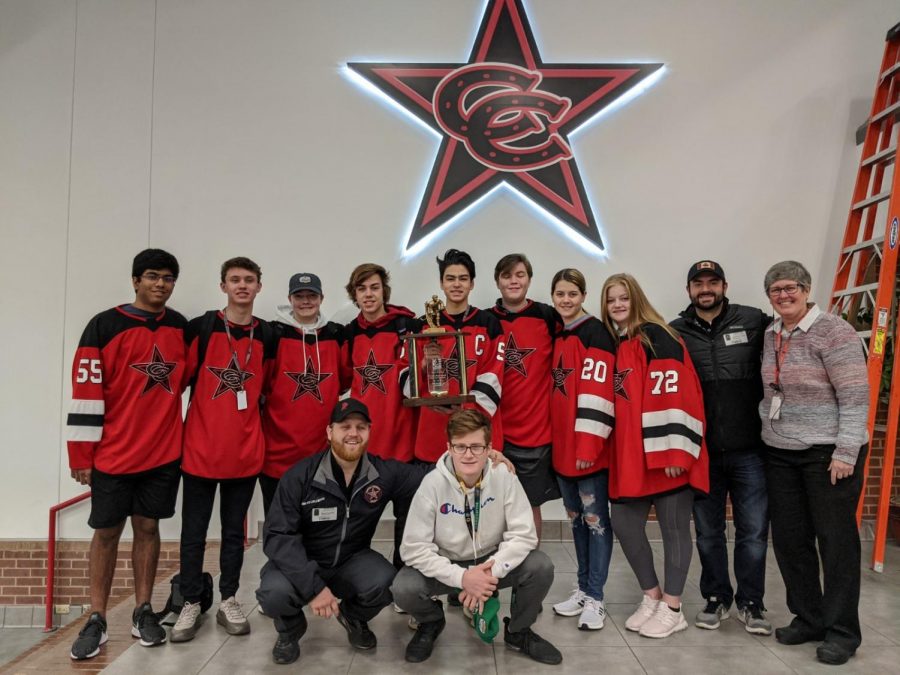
[550,315,616,478]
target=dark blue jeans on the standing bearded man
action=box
[694,451,769,609]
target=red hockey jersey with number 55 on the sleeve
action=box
[68,305,187,474]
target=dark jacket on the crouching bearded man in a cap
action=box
[263,449,431,601]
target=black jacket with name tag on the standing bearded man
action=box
[671,298,772,451]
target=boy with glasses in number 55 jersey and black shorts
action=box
[68,249,187,660]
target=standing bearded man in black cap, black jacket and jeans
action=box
[671,260,772,635]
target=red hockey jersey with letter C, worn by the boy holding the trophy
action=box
[416,307,503,462]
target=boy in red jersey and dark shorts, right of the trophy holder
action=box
[491,253,562,539]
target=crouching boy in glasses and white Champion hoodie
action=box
[391,410,562,664]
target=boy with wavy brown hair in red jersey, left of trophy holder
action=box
[343,263,420,569]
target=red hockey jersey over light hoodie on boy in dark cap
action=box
[262,322,344,478]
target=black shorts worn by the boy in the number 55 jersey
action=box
[88,461,181,530]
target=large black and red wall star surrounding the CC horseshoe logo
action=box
[347,0,664,250]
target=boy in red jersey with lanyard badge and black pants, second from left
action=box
[171,257,271,642]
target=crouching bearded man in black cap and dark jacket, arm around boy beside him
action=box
[256,398,512,664]
